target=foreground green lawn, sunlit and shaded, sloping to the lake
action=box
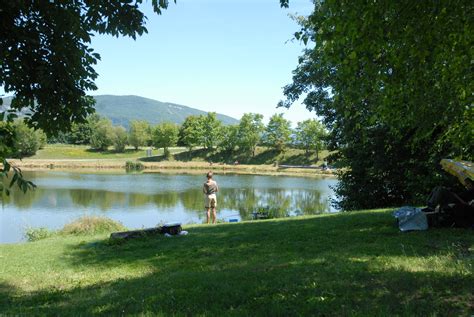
[0,211,474,316]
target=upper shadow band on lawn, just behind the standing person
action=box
[62,212,474,267]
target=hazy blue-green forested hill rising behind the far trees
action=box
[3,95,239,128]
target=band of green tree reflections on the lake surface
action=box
[3,188,331,219]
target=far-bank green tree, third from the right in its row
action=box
[237,113,265,156]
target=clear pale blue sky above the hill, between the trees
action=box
[92,0,315,124]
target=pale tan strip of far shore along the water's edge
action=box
[9,159,336,178]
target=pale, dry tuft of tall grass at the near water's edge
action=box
[59,216,127,235]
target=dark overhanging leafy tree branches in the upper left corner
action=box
[0,0,174,192]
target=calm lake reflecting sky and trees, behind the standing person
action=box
[0,171,337,243]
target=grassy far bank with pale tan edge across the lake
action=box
[10,144,336,177]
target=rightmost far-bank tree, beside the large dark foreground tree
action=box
[296,119,326,159]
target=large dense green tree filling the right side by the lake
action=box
[280,0,474,210]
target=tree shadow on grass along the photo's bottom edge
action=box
[4,260,473,316]
